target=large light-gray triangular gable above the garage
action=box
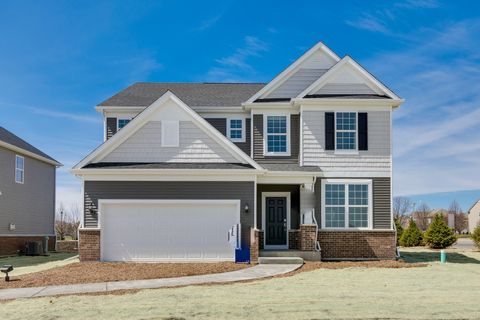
[74,92,260,169]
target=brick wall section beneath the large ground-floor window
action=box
[318,230,396,259]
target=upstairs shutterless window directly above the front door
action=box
[265,116,290,155]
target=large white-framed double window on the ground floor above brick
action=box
[322,180,371,229]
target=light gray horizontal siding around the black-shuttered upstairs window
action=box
[302,111,391,173]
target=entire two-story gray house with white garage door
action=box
[72,43,403,261]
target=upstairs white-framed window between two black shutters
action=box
[335,112,357,150]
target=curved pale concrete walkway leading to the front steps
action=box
[0,264,302,300]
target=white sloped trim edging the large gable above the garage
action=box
[73,91,262,170]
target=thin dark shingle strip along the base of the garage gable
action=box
[83,162,253,169]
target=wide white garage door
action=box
[99,200,240,261]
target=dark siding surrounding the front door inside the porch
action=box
[257,184,300,230]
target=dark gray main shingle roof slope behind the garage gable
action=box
[99,82,265,107]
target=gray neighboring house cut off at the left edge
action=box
[0,127,61,255]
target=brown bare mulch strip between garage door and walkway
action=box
[0,262,249,289]
